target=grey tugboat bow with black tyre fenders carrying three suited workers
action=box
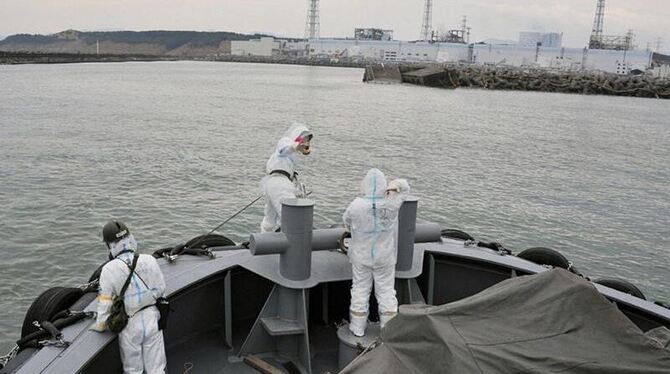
[0,198,670,374]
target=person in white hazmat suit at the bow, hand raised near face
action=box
[260,124,313,232]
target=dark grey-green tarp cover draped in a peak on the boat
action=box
[343,269,670,374]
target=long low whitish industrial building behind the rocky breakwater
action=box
[309,39,652,74]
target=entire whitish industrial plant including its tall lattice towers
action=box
[214,0,666,75]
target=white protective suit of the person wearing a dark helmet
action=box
[92,235,167,374]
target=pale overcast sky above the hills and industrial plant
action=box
[0,0,670,52]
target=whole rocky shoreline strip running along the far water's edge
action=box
[0,51,670,99]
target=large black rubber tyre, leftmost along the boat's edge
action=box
[21,287,84,338]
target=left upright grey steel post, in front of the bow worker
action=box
[279,199,314,280]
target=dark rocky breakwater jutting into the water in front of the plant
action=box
[363,64,670,99]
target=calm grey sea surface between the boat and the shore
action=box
[0,62,670,354]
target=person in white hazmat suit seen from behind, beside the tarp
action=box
[343,169,409,336]
